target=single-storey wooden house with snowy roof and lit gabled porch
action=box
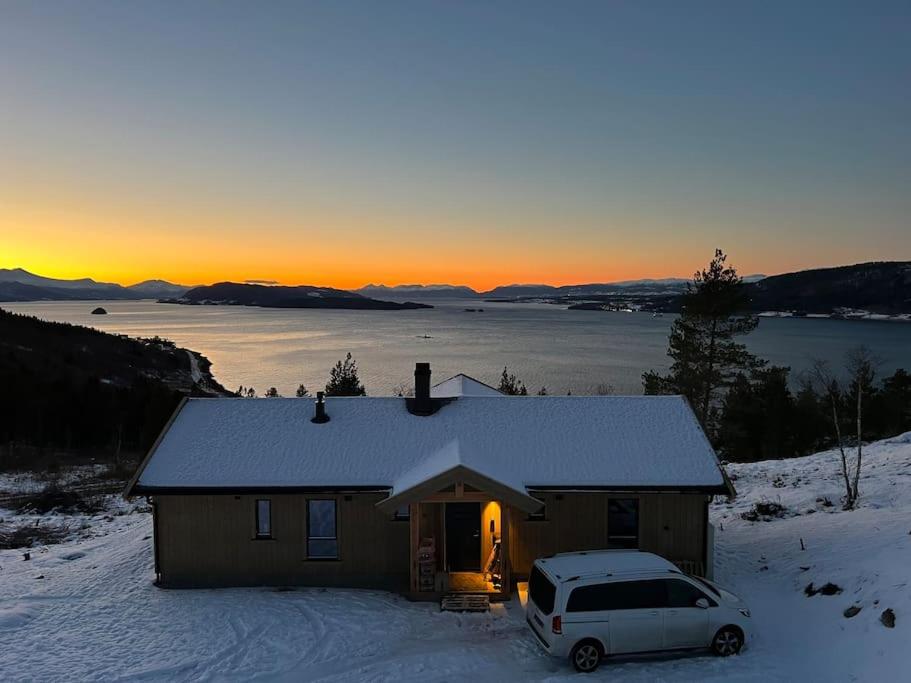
[125,363,733,598]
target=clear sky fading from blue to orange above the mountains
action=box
[0,0,911,288]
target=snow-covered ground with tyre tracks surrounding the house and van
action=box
[0,433,911,681]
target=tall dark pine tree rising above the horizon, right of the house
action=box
[642,249,765,434]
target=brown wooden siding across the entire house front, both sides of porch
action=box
[155,493,708,592]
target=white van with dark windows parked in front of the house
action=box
[526,550,750,672]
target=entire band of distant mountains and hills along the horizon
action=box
[0,261,911,315]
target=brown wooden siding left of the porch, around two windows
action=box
[155,494,409,590]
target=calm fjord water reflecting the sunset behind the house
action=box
[2,300,911,396]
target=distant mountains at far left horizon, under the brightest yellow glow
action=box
[0,268,191,301]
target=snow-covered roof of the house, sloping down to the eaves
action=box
[128,395,725,493]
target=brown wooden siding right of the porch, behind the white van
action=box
[509,493,708,579]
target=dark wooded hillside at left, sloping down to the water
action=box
[0,309,227,463]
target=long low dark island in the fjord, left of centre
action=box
[169,282,433,311]
